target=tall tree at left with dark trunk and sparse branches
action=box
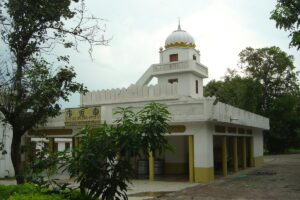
[0,0,107,184]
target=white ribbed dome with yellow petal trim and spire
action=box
[165,25,196,48]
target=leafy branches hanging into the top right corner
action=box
[271,0,300,50]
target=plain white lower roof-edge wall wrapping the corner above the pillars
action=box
[80,98,269,129]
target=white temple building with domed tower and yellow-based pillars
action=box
[0,25,269,183]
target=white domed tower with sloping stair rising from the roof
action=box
[137,24,208,98]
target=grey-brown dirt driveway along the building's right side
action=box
[158,154,300,200]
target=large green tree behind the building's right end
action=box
[205,47,300,153]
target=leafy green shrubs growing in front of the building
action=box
[22,102,171,200]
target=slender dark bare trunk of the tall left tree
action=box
[11,130,25,184]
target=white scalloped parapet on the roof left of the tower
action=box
[81,83,178,106]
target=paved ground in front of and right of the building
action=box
[0,154,300,200]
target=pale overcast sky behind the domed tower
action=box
[62,0,300,107]
